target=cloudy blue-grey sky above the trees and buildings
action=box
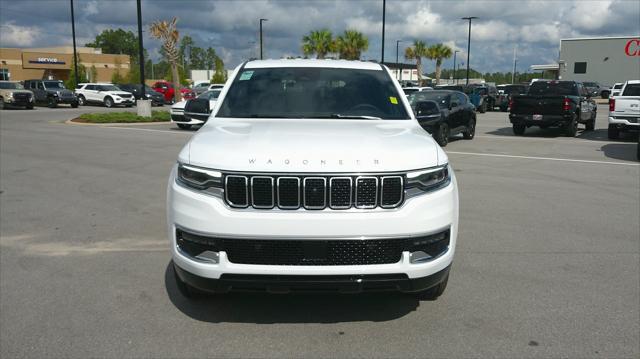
[0,0,640,73]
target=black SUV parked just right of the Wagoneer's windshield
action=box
[409,90,476,147]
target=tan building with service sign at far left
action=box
[0,46,131,82]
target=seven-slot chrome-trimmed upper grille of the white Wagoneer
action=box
[224,174,404,210]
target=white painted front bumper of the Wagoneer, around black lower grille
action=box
[167,168,458,288]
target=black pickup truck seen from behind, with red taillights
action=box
[509,81,598,137]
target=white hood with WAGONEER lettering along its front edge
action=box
[185,118,447,173]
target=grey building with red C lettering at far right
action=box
[531,35,640,86]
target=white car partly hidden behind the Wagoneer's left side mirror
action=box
[170,89,222,130]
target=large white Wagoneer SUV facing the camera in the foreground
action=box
[167,60,458,299]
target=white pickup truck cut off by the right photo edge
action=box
[608,80,640,140]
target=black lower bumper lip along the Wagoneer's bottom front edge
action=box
[174,264,451,293]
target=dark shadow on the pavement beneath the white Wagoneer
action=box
[164,262,419,324]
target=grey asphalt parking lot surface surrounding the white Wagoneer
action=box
[0,106,640,358]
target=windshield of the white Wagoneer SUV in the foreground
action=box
[216,67,410,119]
